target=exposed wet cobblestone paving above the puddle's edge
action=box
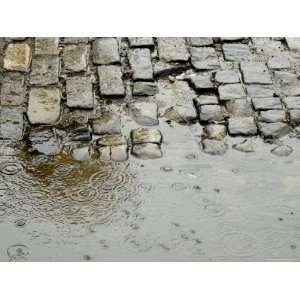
[0,37,300,161]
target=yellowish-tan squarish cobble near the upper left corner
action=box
[4,43,31,72]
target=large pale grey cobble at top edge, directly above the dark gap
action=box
[157,37,189,62]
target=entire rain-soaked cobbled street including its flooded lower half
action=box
[0,38,300,261]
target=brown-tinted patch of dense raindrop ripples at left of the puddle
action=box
[0,154,137,224]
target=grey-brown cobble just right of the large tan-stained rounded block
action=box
[66,76,94,109]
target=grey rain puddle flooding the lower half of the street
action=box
[0,124,300,261]
